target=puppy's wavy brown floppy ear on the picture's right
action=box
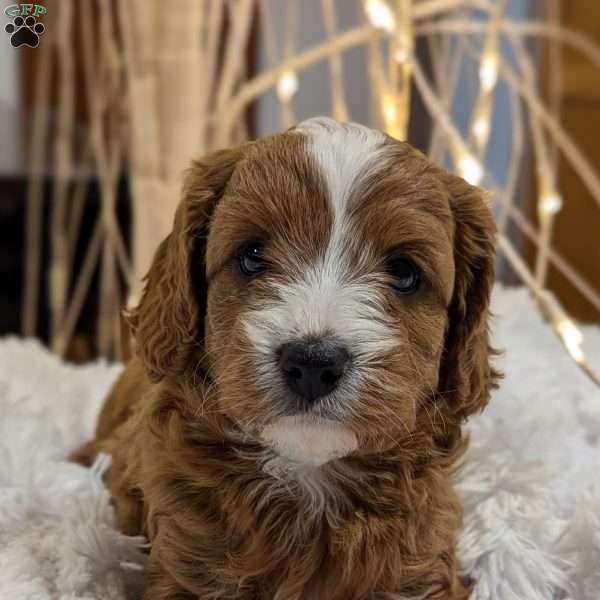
[439,173,500,425]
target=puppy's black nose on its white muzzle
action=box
[279,341,350,402]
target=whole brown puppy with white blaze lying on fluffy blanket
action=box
[76,118,497,600]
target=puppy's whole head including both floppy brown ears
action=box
[131,119,495,464]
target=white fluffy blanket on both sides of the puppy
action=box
[0,289,600,600]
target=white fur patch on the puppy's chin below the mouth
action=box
[261,416,357,467]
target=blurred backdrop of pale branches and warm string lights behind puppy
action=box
[0,0,600,379]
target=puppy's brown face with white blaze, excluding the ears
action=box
[206,122,454,461]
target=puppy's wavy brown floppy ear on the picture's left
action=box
[128,148,242,381]
